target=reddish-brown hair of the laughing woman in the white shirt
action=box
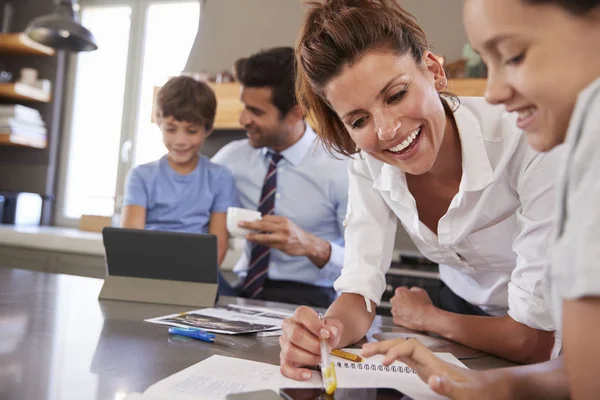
[296,0,434,156]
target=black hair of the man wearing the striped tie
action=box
[235,47,298,118]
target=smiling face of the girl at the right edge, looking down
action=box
[464,0,600,151]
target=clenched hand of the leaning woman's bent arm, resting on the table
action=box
[390,287,436,331]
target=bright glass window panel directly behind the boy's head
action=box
[133,1,200,165]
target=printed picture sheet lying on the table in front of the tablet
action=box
[145,305,285,335]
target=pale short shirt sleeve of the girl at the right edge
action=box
[552,81,600,300]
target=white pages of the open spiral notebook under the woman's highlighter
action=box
[145,349,462,400]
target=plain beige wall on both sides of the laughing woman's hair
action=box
[186,0,467,74]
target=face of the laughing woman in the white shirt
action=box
[325,50,446,175]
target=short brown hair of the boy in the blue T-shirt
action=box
[156,76,217,132]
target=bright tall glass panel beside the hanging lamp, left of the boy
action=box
[62,6,131,218]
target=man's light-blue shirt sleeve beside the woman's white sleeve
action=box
[322,161,348,280]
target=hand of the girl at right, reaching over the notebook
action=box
[361,339,512,400]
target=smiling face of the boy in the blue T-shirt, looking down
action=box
[158,116,210,166]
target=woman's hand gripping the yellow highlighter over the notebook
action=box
[279,306,344,381]
